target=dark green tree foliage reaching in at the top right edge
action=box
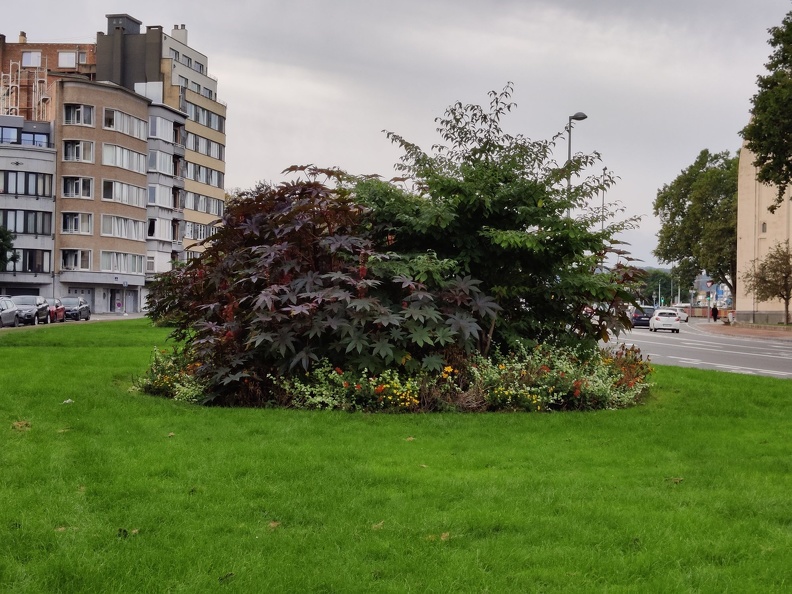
[741,12,792,212]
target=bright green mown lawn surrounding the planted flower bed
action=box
[0,320,792,592]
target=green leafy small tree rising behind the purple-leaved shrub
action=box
[357,85,640,345]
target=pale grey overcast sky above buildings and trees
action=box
[0,0,792,266]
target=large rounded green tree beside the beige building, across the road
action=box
[653,149,739,294]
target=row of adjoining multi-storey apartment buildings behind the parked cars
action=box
[0,14,226,312]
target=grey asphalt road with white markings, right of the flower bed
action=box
[619,320,792,379]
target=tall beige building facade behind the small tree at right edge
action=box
[736,146,792,324]
